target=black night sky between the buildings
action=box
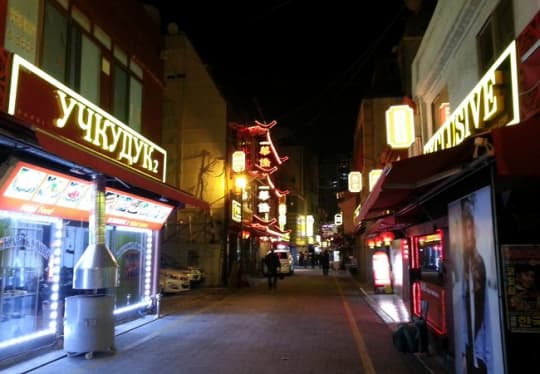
[144,0,408,155]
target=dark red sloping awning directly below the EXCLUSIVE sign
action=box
[359,138,474,221]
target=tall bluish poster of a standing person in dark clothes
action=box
[448,187,504,374]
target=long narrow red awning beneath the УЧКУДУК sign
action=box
[35,131,210,210]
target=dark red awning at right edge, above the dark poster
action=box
[492,118,540,177]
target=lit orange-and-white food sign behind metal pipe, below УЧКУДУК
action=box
[0,161,173,230]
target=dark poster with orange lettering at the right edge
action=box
[502,245,540,333]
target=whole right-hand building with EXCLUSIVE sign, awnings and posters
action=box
[359,0,540,373]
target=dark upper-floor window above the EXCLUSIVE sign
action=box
[476,0,514,75]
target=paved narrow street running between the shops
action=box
[7,269,438,374]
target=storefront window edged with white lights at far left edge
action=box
[0,211,60,344]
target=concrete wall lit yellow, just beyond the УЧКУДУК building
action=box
[162,33,227,284]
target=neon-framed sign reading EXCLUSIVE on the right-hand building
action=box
[424,42,519,153]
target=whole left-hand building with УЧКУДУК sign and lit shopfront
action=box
[0,0,209,359]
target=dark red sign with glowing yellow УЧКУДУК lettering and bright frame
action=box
[8,55,167,182]
